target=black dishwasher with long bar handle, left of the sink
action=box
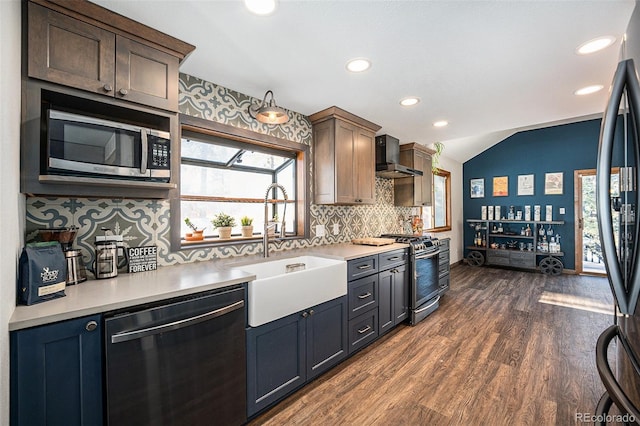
[105,286,247,426]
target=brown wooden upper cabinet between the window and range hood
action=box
[309,107,380,204]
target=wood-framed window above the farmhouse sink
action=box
[171,116,309,249]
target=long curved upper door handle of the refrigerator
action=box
[596,59,640,314]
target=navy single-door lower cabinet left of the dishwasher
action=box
[10,315,103,426]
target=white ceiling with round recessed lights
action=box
[94,0,635,162]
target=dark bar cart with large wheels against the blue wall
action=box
[465,219,564,275]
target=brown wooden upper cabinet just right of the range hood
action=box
[393,143,433,206]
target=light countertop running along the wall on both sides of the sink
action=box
[9,243,408,331]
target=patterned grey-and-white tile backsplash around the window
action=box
[26,74,412,266]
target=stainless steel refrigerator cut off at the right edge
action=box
[596,8,640,424]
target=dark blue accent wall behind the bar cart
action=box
[463,119,600,269]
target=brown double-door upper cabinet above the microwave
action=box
[27,0,194,111]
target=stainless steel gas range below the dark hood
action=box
[382,234,440,325]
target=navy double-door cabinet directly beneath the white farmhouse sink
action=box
[247,296,348,416]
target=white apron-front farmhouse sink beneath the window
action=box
[235,256,347,327]
